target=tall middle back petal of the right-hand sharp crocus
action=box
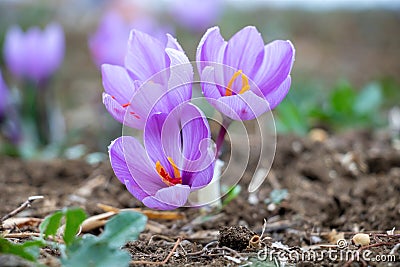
[224,26,264,77]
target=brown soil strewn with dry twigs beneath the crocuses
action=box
[0,131,400,266]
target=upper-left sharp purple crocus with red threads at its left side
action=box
[102,30,193,129]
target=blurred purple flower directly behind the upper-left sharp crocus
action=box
[89,12,171,67]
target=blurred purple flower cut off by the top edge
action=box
[171,0,223,32]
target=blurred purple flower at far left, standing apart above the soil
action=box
[4,23,65,82]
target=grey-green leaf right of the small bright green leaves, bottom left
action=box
[100,211,147,247]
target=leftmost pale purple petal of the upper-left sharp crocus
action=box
[101,64,137,104]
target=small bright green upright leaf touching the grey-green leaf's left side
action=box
[63,208,86,246]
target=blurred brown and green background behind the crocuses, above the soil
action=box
[0,0,400,157]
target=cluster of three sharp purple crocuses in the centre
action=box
[102,27,294,209]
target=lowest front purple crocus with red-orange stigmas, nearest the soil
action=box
[109,103,215,210]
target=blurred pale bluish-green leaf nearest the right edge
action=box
[354,82,383,115]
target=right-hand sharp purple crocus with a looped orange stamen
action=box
[196,26,295,120]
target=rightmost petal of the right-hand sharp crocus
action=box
[253,40,295,95]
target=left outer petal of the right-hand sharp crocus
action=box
[196,27,227,73]
